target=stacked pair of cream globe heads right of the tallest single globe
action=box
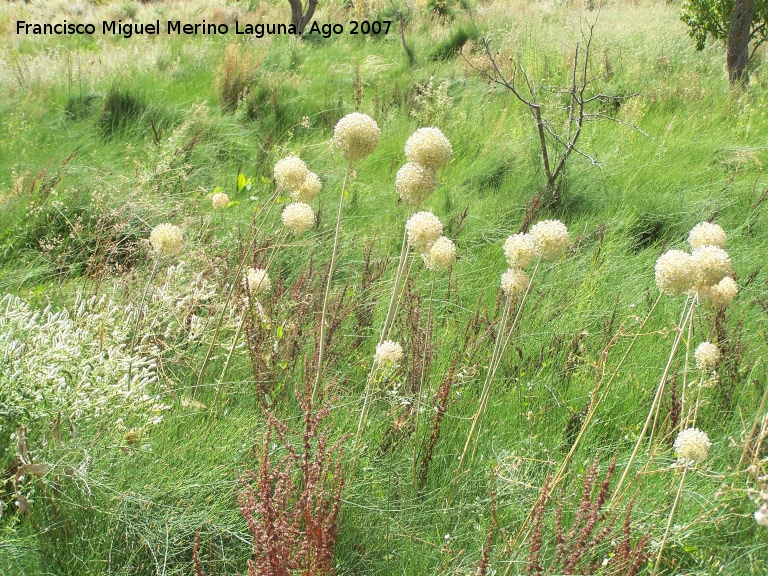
[395,128,453,206]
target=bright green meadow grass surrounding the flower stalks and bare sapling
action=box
[0,3,768,576]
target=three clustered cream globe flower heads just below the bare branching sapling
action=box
[501,220,571,298]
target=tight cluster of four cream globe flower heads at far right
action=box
[656,222,738,309]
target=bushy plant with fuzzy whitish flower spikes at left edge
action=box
[0,295,168,446]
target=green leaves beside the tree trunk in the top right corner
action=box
[680,0,768,50]
